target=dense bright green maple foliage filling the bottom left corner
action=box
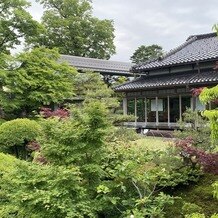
[0,152,95,218]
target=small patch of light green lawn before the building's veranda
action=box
[132,136,172,151]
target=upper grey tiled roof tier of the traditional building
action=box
[131,33,218,73]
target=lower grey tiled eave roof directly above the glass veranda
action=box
[115,70,218,91]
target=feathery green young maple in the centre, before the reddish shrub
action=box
[40,102,109,190]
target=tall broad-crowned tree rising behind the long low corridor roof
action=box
[33,0,115,59]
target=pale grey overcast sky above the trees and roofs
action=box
[30,0,218,61]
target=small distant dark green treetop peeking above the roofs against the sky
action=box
[130,44,163,64]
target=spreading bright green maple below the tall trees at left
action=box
[0,48,76,117]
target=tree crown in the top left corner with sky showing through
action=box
[0,0,43,53]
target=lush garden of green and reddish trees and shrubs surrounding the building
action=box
[0,0,218,218]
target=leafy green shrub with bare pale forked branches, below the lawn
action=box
[99,141,202,217]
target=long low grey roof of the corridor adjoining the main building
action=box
[60,55,132,75]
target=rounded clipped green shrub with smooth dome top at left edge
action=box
[0,119,41,157]
